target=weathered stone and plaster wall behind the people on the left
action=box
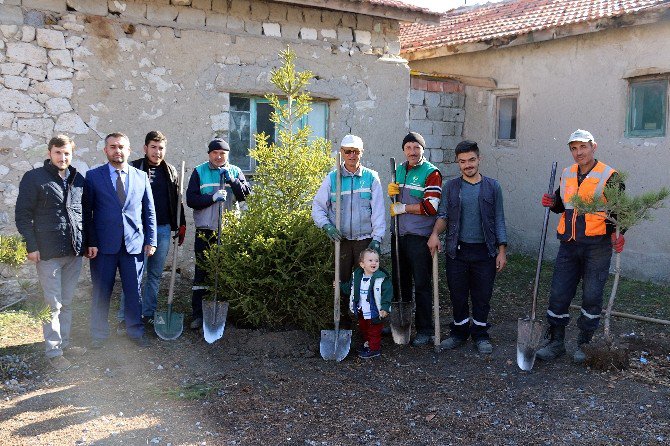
[0,0,409,254]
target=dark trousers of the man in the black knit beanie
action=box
[391,234,433,336]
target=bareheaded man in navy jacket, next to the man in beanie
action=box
[428,141,507,354]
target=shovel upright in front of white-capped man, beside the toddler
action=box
[319,153,351,362]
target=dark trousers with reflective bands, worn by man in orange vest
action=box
[547,240,612,332]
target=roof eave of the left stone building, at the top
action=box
[272,0,441,25]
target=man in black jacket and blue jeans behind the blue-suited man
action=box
[116,130,186,334]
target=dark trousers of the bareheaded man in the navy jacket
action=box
[446,242,496,341]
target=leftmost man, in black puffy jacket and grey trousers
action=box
[15,135,86,371]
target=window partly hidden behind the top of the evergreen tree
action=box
[228,94,328,171]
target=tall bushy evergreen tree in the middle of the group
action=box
[204,50,333,331]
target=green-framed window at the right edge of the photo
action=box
[626,79,668,137]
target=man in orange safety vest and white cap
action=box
[537,129,625,363]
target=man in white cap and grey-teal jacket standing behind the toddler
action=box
[312,135,386,314]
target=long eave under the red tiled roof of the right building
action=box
[400,3,670,62]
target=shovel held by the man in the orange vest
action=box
[516,161,557,372]
